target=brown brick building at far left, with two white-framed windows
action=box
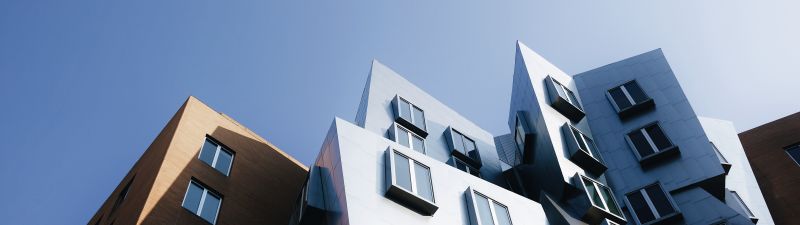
[88,97,308,225]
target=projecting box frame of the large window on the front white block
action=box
[384,147,439,216]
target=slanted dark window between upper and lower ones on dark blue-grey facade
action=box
[627,123,679,164]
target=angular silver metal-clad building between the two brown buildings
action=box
[291,43,773,225]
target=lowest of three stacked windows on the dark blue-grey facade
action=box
[626,183,679,224]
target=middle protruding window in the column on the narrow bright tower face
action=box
[562,123,608,175]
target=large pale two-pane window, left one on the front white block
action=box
[392,151,434,202]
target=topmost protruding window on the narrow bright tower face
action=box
[545,76,585,121]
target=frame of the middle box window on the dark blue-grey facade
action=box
[625,121,680,166]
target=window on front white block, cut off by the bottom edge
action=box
[467,188,511,225]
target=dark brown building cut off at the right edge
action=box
[739,113,800,224]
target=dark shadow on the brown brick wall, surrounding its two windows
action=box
[140,126,307,225]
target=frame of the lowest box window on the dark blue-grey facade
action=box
[625,182,682,225]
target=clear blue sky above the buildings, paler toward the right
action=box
[0,0,800,224]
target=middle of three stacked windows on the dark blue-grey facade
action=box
[628,123,675,159]
